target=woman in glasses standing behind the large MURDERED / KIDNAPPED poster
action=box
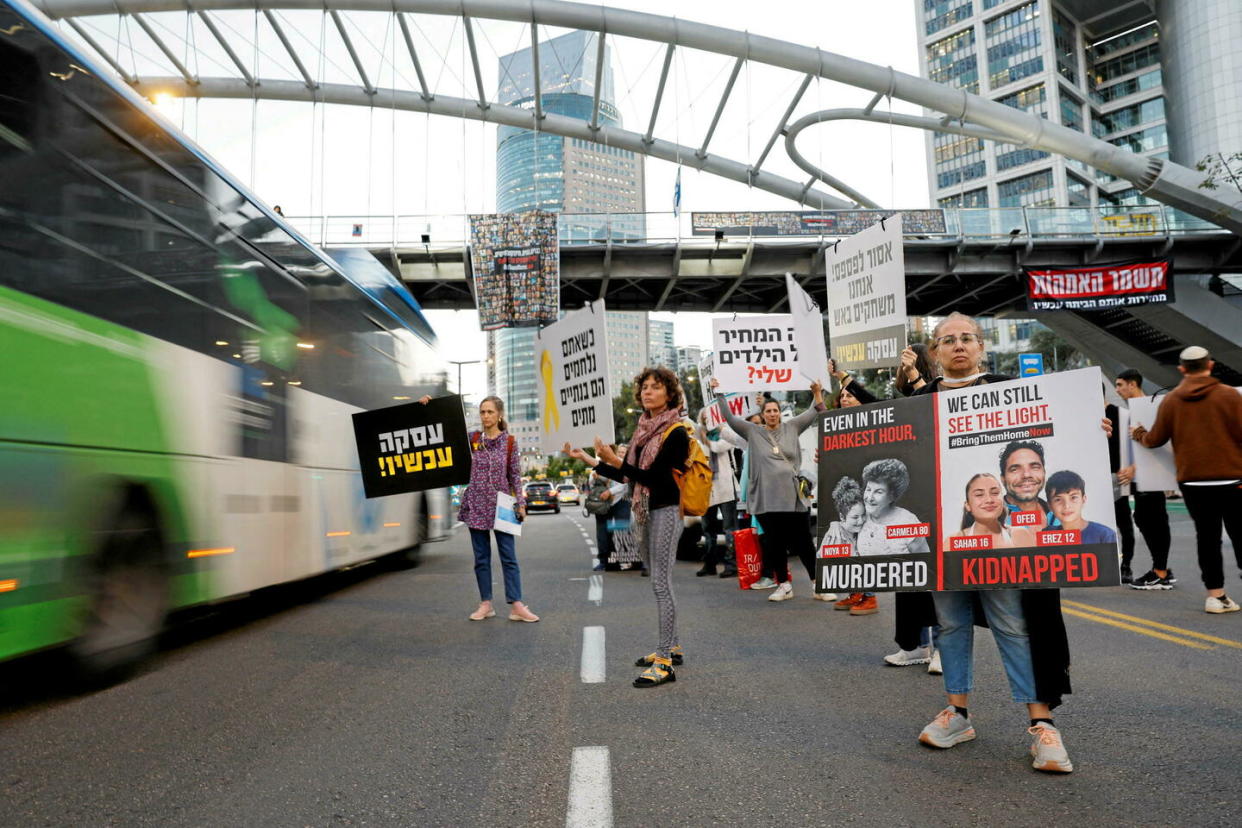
[914,313,1073,773]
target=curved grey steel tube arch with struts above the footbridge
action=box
[34,0,1242,233]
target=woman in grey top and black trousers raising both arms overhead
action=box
[712,377,823,601]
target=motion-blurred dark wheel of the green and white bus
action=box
[70,509,169,683]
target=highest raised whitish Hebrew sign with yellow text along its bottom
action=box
[825,214,905,370]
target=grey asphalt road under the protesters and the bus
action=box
[0,513,1242,828]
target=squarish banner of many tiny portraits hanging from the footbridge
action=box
[469,210,560,330]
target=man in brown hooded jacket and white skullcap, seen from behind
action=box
[1130,345,1242,613]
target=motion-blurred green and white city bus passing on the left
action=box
[0,0,451,674]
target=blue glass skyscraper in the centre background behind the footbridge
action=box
[487,31,647,454]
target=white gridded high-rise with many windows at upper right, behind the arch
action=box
[915,0,1187,207]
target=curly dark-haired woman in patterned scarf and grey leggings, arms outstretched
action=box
[564,367,691,688]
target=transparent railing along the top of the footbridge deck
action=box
[286,205,1228,250]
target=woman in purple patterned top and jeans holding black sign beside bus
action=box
[419,397,539,622]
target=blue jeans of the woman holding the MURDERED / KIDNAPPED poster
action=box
[932,590,1038,704]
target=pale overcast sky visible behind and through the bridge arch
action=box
[72,0,928,396]
